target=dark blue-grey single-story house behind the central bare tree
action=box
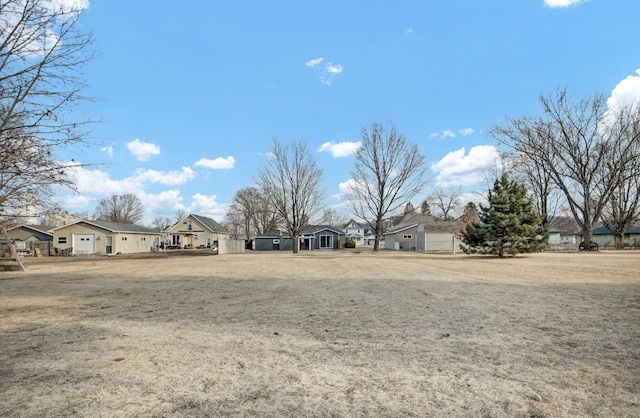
[254,225,346,251]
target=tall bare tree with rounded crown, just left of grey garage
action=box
[350,122,426,251]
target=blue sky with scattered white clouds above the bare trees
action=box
[59,0,640,223]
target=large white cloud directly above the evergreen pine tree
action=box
[431,145,500,186]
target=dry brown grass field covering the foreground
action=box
[0,250,640,417]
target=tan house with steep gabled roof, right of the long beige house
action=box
[162,214,231,248]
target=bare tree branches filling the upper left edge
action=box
[0,0,93,219]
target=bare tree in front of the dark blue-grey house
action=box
[258,138,324,253]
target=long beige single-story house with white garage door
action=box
[51,220,161,255]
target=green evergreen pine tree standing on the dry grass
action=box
[462,174,549,257]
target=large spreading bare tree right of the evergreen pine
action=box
[490,89,638,243]
